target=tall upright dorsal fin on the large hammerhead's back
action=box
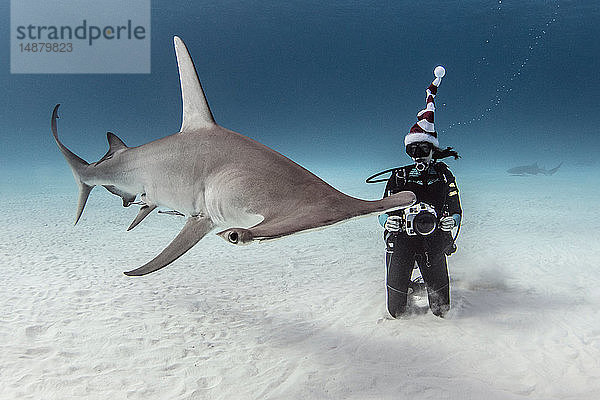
[173,36,216,132]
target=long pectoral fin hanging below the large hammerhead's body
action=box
[125,217,214,276]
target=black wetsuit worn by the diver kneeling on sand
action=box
[384,162,462,317]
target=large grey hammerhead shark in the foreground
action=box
[51,37,415,276]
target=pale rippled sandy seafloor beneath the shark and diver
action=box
[0,166,600,400]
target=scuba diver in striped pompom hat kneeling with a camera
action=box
[367,66,462,318]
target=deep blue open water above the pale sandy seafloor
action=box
[0,0,600,184]
